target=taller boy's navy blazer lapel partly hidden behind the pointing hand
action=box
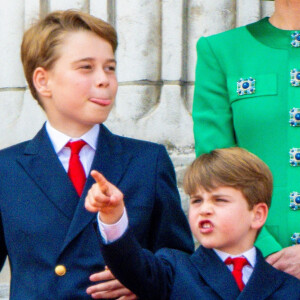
[61,125,132,251]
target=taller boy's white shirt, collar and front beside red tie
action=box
[46,121,100,177]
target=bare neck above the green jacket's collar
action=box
[269,0,300,30]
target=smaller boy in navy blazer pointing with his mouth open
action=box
[85,148,300,300]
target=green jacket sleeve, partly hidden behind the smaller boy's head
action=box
[192,37,282,256]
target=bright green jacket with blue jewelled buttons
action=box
[193,18,300,256]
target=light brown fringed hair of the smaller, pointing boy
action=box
[183,147,273,209]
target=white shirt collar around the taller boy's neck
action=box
[46,121,100,153]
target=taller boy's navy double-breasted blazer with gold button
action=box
[0,125,194,300]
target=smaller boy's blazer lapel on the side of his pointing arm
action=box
[191,246,240,300]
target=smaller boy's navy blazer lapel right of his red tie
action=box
[238,249,288,300]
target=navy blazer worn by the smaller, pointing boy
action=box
[98,230,300,300]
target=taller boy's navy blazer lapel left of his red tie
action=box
[17,126,79,220]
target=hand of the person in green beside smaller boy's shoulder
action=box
[266,245,300,279]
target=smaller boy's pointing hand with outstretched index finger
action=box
[85,171,124,224]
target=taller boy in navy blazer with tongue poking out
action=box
[0,10,194,300]
